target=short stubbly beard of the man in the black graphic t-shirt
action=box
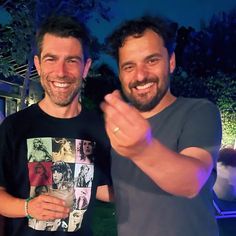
[41,74,82,107]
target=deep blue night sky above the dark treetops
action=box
[89,0,236,40]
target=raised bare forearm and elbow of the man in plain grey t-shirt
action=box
[131,139,212,197]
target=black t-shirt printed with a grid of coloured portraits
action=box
[0,104,111,236]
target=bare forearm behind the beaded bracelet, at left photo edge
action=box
[0,188,26,218]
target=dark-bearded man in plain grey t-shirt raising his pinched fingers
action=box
[101,16,221,236]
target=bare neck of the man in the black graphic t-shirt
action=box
[39,97,81,118]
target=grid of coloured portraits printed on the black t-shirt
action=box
[27,137,95,232]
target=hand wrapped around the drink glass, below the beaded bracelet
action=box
[28,195,70,220]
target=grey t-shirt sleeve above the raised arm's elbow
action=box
[179,100,222,163]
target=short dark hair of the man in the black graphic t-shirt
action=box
[36,15,90,60]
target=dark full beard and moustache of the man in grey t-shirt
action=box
[121,76,169,112]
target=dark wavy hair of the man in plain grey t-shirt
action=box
[105,16,178,61]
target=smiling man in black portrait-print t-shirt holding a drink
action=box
[0,16,110,236]
